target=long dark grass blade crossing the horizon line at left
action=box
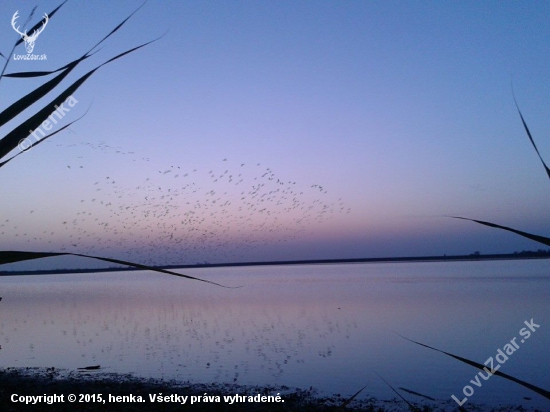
[0,250,234,289]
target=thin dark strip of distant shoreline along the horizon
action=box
[0,252,550,276]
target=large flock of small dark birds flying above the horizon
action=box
[0,143,350,265]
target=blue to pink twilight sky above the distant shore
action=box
[0,0,550,269]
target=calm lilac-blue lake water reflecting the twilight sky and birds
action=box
[0,260,550,408]
